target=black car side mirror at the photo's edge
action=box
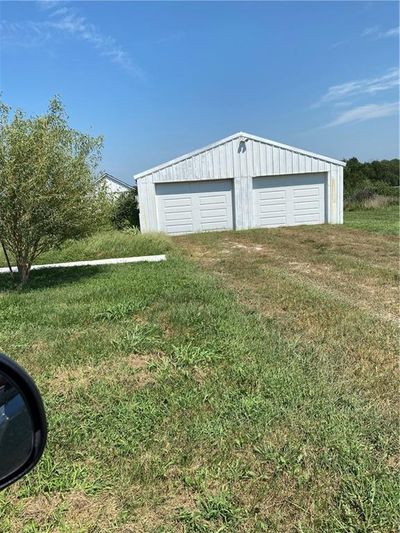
[0,353,47,490]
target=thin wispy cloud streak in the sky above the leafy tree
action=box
[0,0,144,78]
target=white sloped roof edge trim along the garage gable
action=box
[134,131,346,179]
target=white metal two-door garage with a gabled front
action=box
[135,132,345,235]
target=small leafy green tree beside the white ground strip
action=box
[0,98,105,283]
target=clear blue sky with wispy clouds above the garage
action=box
[0,1,399,181]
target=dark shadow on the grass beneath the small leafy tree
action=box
[0,266,106,293]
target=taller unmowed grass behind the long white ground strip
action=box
[0,231,172,266]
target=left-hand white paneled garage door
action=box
[156,180,233,235]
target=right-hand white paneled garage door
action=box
[253,174,325,228]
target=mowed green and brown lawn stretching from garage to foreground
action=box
[0,215,399,533]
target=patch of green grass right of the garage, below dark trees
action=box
[344,205,400,235]
